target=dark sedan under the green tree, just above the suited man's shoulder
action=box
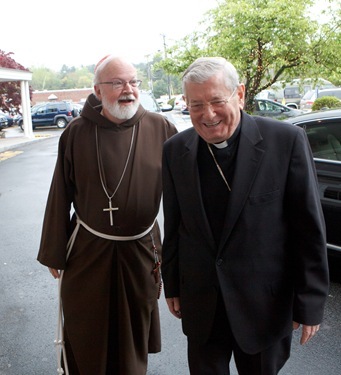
[252,99,303,119]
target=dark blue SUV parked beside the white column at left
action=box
[18,101,76,130]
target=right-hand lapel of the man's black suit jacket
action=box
[219,113,264,251]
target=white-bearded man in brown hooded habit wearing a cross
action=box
[38,56,177,375]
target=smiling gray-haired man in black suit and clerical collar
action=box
[162,58,329,375]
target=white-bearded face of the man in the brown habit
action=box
[94,58,139,124]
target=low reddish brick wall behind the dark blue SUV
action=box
[31,88,93,105]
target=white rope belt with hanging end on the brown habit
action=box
[54,215,156,375]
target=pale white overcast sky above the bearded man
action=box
[0,0,217,71]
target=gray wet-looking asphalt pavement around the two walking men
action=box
[0,113,341,375]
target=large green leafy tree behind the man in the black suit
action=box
[155,0,340,111]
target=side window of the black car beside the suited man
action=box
[305,122,341,160]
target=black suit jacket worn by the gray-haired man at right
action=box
[162,112,329,354]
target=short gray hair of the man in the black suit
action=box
[182,57,240,96]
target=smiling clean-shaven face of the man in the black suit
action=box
[184,73,245,143]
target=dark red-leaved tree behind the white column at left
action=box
[0,50,32,113]
